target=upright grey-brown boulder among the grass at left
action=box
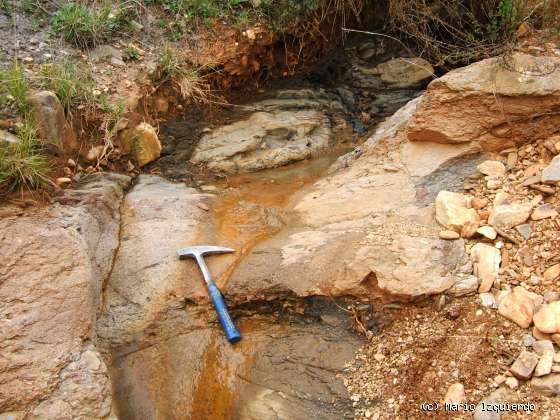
[28,90,78,151]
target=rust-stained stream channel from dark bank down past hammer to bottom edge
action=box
[98,37,426,420]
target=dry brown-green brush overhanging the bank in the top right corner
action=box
[388,0,560,68]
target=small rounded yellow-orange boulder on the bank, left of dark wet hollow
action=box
[120,122,161,167]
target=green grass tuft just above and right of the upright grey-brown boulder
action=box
[37,60,95,115]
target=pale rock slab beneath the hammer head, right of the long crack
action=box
[98,175,215,345]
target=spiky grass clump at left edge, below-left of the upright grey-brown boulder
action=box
[0,119,49,193]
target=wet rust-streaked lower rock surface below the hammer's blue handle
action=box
[113,310,360,419]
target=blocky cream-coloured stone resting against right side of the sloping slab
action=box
[436,191,479,232]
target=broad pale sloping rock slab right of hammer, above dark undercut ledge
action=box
[225,100,482,301]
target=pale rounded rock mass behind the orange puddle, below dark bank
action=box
[191,91,342,173]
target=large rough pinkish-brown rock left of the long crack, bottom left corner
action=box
[0,174,130,420]
